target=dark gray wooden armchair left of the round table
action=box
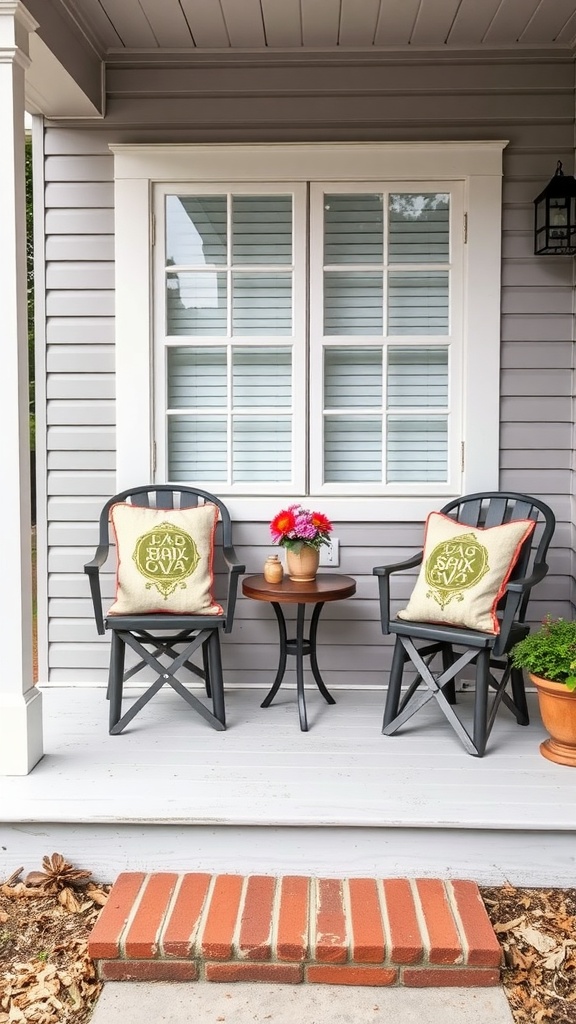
[84,484,245,735]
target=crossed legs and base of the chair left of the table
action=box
[107,621,225,736]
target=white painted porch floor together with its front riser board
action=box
[0,687,576,886]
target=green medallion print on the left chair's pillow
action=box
[132,522,200,600]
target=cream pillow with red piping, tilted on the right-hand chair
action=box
[398,512,536,633]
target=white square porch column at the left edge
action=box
[0,0,43,775]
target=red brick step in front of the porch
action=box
[88,872,501,987]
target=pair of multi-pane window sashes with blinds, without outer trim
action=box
[152,176,459,495]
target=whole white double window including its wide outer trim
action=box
[114,143,502,518]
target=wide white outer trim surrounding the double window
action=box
[111,140,506,521]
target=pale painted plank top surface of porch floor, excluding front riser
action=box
[0,688,576,830]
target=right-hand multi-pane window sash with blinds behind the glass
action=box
[311,185,452,495]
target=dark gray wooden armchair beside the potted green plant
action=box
[373,492,556,757]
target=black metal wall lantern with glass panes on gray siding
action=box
[534,160,576,256]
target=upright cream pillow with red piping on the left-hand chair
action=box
[108,502,222,615]
